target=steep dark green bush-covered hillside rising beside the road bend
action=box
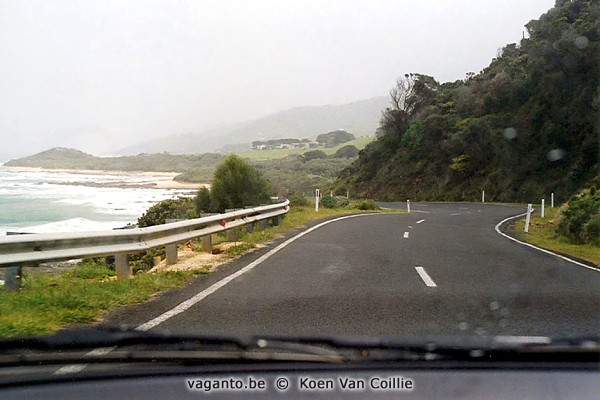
[333,0,600,202]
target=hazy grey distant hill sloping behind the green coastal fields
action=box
[117,96,389,154]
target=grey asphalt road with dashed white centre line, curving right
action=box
[104,203,600,337]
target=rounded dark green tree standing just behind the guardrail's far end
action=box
[210,154,271,212]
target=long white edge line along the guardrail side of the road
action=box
[136,214,383,331]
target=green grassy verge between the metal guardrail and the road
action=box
[0,203,390,337]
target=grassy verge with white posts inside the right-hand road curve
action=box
[508,206,600,265]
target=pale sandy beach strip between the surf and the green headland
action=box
[0,166,209,190]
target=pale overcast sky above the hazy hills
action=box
[0,0,554,161]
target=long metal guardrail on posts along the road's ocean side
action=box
[0,200,289,290]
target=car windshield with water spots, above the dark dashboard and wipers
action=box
[0,0,600,394]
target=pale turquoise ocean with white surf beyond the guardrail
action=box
[0,167,193,236]
